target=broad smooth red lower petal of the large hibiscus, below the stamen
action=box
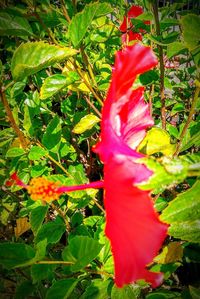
[104,156,167,287]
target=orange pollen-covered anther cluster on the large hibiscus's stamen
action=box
[27,177,60,202]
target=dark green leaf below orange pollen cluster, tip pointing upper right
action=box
[35,217,66,244]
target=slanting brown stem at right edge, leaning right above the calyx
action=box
[174,85,200,157]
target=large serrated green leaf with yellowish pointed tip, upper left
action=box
[11,41,77,81]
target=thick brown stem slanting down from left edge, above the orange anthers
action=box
[0,88,28,149]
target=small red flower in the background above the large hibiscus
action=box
[119,5,150,43]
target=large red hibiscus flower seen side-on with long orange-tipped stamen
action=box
[7,44,167,287]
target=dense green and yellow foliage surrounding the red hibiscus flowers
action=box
[0,0,200,299]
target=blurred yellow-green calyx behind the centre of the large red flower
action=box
[138,157,188,194]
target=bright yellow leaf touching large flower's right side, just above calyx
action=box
[138,127,175,156]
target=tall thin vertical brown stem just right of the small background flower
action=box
[152,1,166,130]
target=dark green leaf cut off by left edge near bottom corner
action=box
[0,242,35,269]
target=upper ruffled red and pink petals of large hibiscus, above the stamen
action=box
[94,44,157,163]
